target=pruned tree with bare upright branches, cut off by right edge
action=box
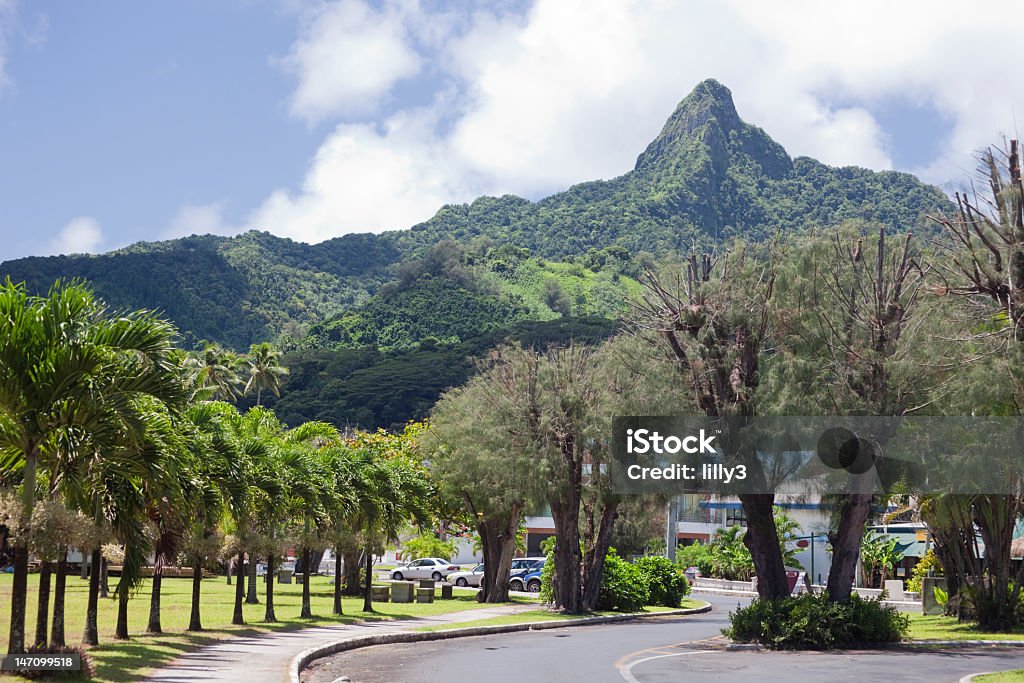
[926,139,1024,630]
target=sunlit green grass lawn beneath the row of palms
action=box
[0,573,527,681]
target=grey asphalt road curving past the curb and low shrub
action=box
[302,595,1024,683]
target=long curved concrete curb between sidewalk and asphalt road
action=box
[288,604,711,683]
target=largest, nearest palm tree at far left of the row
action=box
[0,280,181,653]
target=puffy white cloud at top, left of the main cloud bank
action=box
[281,0,421,121]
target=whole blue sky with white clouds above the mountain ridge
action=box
[0,0,1024,260]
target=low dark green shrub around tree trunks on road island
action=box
[722,593,909,650]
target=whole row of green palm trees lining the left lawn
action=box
[0,282,434,653]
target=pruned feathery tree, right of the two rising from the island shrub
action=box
[766,226,934,602]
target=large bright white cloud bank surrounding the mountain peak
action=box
[253,0,1024,241]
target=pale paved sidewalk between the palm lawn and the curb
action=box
[145,603,538,683]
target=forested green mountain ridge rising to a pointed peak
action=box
[0,81,949,350]
